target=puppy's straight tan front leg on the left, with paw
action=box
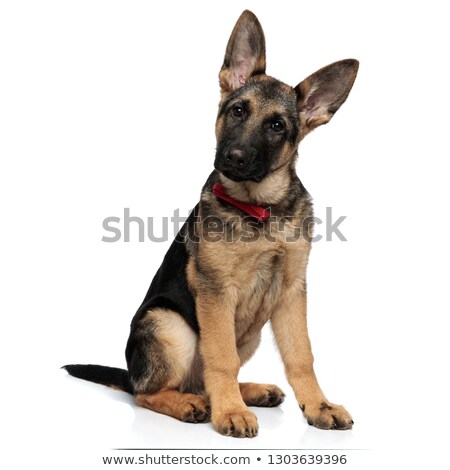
[196,292,258,437]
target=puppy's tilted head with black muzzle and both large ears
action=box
[214,10,358,187]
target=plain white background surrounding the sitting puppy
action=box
[0,0,450,469]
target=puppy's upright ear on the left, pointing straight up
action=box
[219,10,266,97]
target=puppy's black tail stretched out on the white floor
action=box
[62,364,133,394]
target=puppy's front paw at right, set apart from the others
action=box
[300,401,353,430]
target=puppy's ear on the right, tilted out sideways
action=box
[295,59,359,138]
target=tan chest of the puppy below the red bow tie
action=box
[197,202,310,347]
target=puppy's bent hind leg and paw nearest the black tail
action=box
[127,309,210,423]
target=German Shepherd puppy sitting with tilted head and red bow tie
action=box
[65,11,358,437]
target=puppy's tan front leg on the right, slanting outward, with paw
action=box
[271,281,353,429]
